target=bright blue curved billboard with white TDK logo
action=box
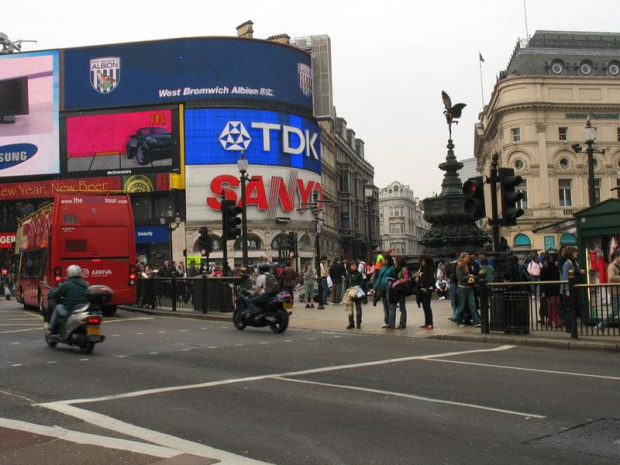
[184,108,321,174]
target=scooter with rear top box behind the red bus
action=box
[45,285,114,354]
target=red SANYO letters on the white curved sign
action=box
[207,174,323,212]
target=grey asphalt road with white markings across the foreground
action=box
[0,302,620,465]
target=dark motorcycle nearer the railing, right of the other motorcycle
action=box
[233,290,293,333]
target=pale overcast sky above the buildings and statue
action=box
[0,0,620,199]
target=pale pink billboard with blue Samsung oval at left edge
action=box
[0,51,59,178]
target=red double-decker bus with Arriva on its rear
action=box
[15,195,136,315]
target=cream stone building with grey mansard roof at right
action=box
[474,31,620,250]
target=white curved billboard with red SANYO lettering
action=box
[186,164,323,224]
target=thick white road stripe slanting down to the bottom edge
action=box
[34,403,266,465]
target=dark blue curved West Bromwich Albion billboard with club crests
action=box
[63,37,312,112]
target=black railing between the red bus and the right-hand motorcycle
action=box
[136,276,239,313]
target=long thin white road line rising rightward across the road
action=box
[41,345,516,406]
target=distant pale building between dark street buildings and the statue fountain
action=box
[379,181,430,255]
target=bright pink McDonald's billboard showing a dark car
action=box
[61,109,180,176]
